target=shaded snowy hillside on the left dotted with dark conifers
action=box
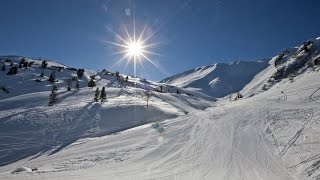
[0,56,212,165]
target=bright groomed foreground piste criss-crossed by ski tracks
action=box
[0,61,320,180]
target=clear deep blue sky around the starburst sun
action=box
[0,0,320,80]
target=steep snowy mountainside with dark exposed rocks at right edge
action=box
[242,38,320,96]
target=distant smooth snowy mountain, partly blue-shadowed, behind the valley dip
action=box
[160,60,268,97]
